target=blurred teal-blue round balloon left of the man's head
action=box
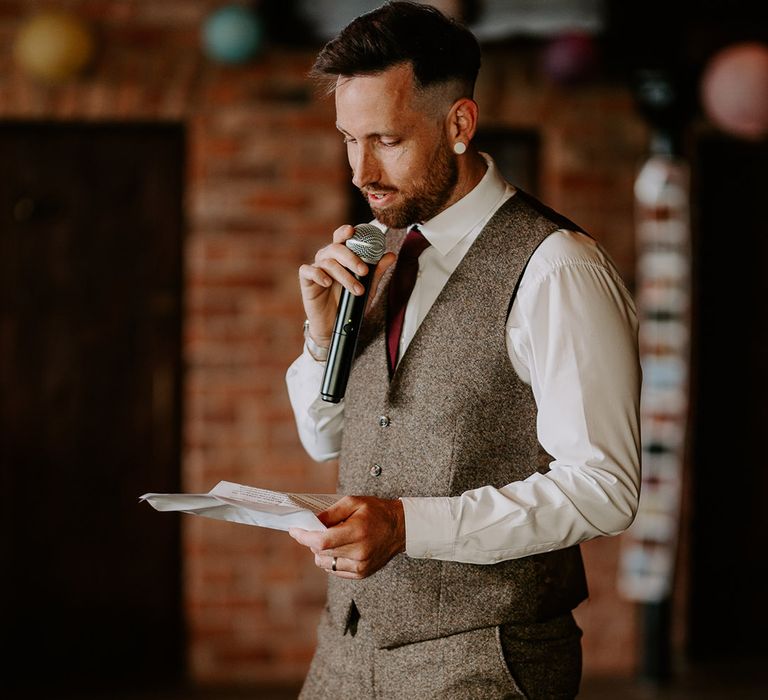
[203,5,263,63]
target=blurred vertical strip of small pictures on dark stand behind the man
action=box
[618,71,692,608]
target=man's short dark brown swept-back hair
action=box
[310,2,480,97]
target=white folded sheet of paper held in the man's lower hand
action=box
[139,481,340,530]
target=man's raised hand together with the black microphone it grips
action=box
[299,224,395,403]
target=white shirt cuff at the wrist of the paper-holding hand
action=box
[400,497,459,559]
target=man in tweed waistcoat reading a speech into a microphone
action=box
[287,2,640,698]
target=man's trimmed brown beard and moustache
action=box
[361,136,459,228]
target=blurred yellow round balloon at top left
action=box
[13,11,94,82]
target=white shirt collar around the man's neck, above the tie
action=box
[419,153,507,256]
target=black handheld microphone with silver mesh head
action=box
[320,224,385,403]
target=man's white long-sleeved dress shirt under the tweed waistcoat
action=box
[286,156,640,564]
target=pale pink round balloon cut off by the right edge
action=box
[700,42,768,139]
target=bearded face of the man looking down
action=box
[336,64,458,228]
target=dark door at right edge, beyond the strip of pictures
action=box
[689,134,768,663]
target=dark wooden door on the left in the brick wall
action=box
[0,123,184,690]
